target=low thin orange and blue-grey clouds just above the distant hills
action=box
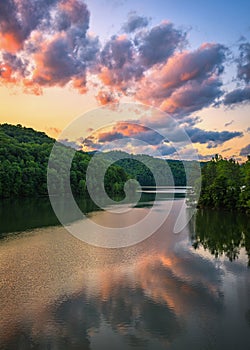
[81,122,243,155]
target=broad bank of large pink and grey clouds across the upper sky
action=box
[0,0,229,117]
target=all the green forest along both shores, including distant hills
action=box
[0,124,250,212]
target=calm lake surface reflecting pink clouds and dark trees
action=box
[0,194,250,350]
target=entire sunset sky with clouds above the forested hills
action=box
[0,0,250,161]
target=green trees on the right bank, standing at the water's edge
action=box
[198,155,250,212]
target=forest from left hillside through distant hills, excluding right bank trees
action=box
[0,124,192,198]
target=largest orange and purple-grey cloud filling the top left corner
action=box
[0,0,99,93]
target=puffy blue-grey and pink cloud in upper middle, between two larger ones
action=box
[99,22,185,94]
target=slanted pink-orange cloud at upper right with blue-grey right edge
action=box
[136,44,225,116]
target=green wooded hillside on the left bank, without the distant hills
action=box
[0,124,129,198]
